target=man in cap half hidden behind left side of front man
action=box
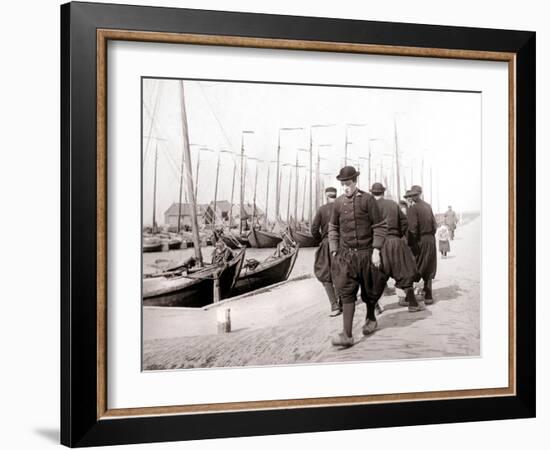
[311,187,342,317]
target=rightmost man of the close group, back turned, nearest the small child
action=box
[407,186,437,305]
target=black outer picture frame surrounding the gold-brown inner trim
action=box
[60,3,536,447]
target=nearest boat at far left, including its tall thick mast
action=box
[143,80,245,307]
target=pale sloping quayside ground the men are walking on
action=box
[143,218,480,370]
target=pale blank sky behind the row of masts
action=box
[142,78,481,225]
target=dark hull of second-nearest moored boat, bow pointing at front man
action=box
[232,245,299,295]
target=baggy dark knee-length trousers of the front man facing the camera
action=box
[332,248,386,306]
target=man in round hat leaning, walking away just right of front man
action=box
[370,183,426,312]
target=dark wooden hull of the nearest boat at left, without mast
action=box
[143,248,245,308]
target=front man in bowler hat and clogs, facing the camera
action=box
[328,166,387,347]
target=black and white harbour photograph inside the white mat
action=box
[143,76,482,371]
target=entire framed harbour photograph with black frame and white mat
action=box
[61,3,536,447]
